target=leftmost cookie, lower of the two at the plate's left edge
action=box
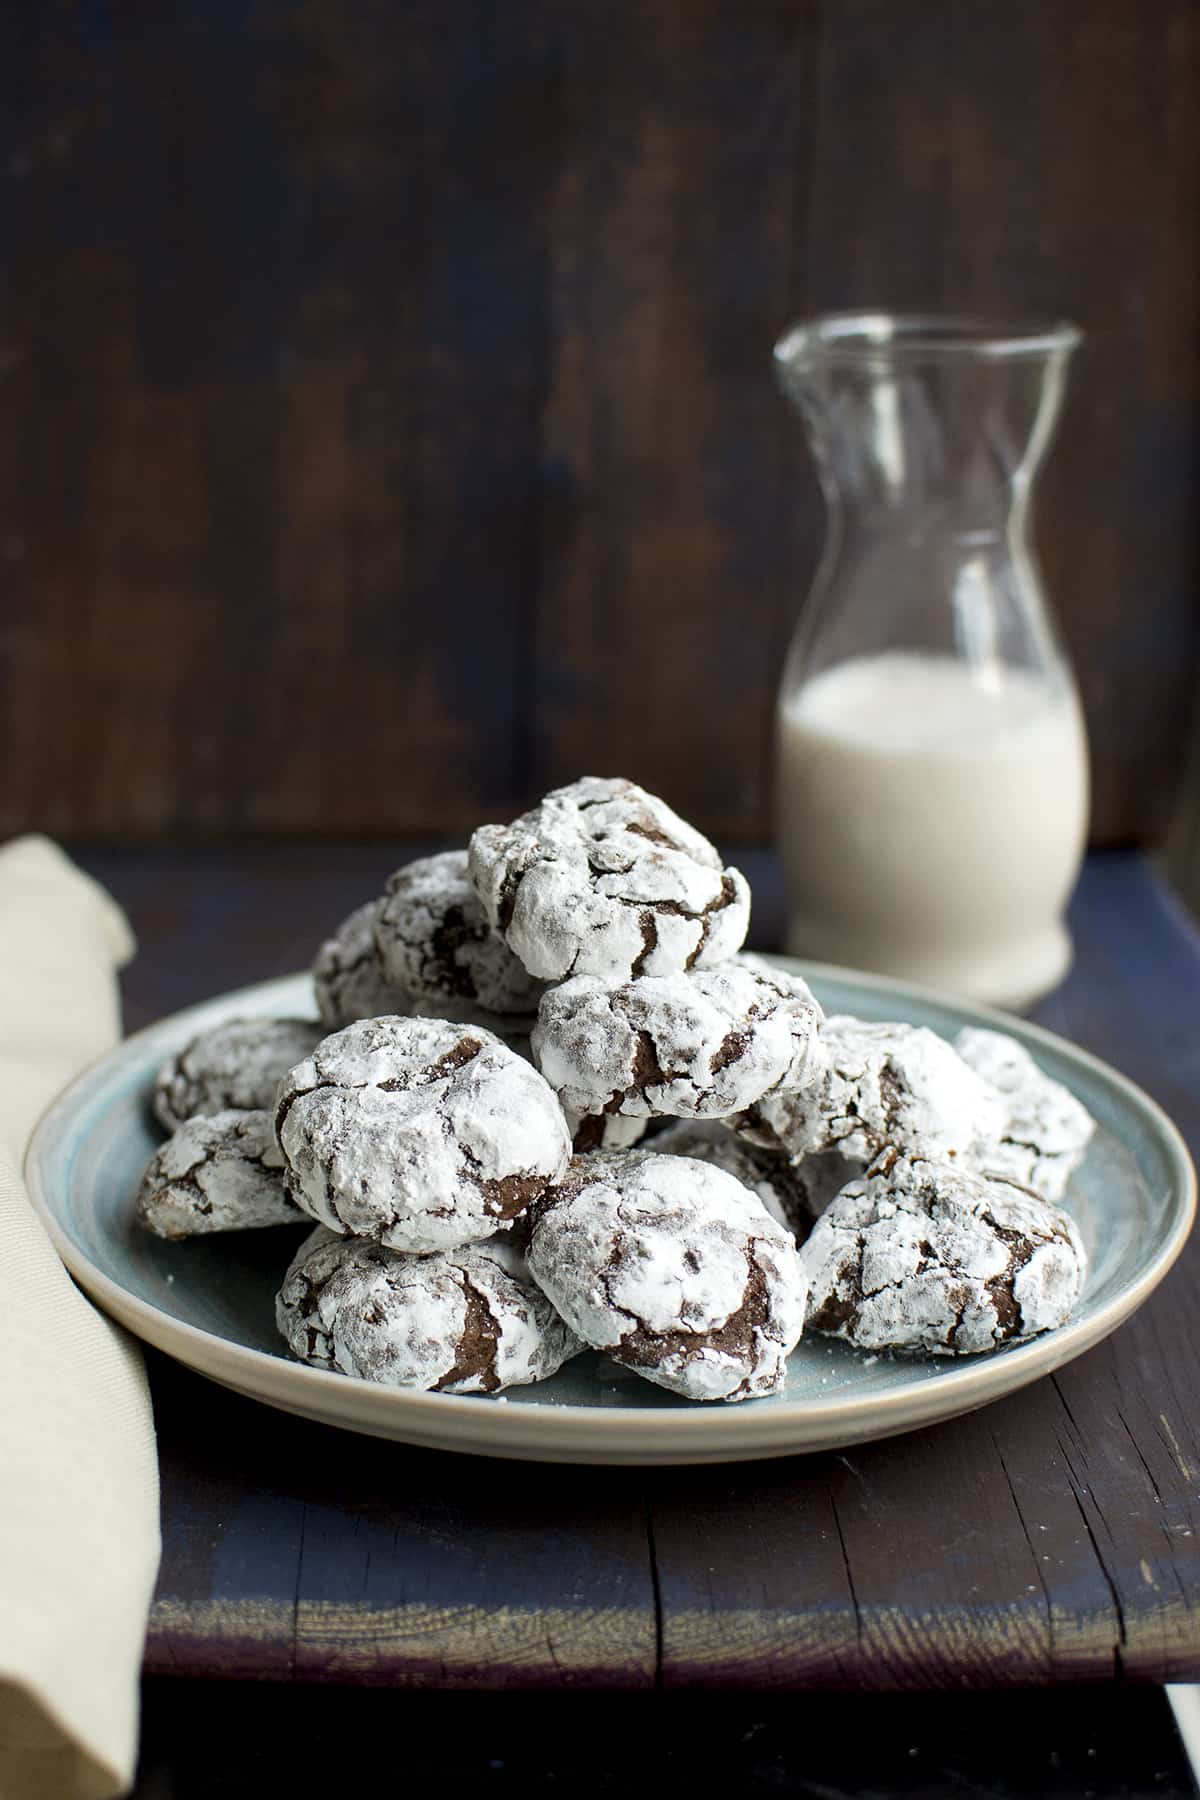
[137,1112,304,1238]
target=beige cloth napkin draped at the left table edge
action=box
[0,837,158,1800]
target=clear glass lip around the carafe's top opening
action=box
[774,311,1083,371]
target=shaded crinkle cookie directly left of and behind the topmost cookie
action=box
[374,850,543,1013]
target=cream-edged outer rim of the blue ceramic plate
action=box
[23,952,1196,1462]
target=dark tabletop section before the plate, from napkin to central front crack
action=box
[146,1354,657,1690]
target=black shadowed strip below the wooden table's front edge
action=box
[133,1679,1195,1800]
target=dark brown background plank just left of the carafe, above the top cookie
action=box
[534,4,822,833]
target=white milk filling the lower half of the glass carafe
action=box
[779,652,1088,1006]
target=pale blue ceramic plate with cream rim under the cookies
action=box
[27,958,1196,1463]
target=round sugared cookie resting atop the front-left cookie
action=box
[275,1017,570,1253]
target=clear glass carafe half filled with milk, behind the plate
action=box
[775,313,1088,1008]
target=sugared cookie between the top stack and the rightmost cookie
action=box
[738,1015,1004,1166]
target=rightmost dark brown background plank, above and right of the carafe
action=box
[804,0,1200,844]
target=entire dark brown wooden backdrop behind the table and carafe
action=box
[0,0,1200,841]
